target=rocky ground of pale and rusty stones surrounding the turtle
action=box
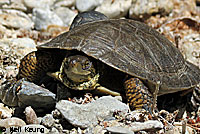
[0,0,200,134]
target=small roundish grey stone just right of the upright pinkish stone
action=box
[41,114,55,128]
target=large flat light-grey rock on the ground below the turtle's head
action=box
[56,96,129,128]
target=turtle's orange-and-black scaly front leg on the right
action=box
[124,78,153,112]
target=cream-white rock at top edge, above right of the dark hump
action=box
[95,0,132,18]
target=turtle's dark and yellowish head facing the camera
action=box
[63,55,95,83]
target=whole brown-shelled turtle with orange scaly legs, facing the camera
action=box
[18,13,200,110]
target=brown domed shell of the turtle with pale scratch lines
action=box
[38,19,200,95]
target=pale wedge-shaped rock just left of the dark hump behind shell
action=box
[54,7,77,26]
